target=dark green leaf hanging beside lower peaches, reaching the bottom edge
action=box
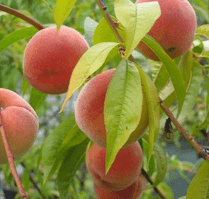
[57,139,89,199]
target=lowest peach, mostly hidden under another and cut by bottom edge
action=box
[94,174,146,199]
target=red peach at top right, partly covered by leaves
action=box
[136,0,197,60]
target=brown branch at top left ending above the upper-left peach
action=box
[0,4,45,30]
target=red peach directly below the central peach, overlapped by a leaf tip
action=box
[86,142,143,191]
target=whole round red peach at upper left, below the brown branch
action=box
[23,26,89,94]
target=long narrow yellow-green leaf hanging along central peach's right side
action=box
[135,64,160,162]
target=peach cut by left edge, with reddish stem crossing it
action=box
[0,88,38,164]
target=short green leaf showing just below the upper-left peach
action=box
[29,88,48,111]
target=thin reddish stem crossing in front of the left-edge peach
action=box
[0,109,28,199]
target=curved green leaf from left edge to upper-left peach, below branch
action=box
[0,27,38,52]
